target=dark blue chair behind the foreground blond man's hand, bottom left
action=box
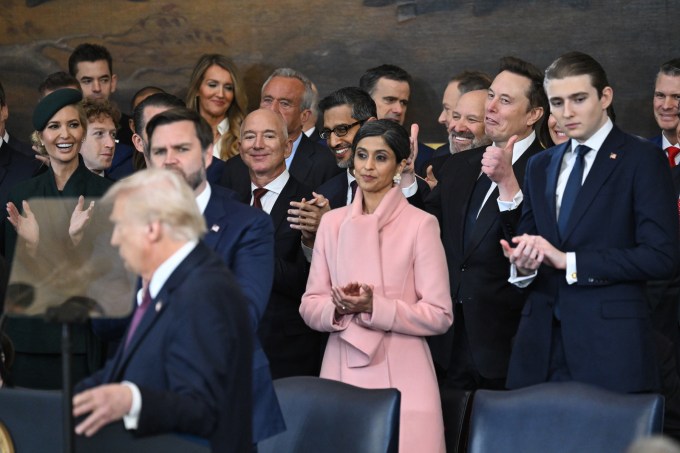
[0,389,210,453]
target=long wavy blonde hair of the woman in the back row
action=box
[186,54,248,160]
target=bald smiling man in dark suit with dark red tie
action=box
[227,109,328,379]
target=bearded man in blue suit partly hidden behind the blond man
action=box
[146,107,285,443]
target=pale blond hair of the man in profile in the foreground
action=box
[102,168,206,241]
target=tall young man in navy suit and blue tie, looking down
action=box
[502,52,680,392]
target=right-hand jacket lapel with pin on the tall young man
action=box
[562,128,625,242]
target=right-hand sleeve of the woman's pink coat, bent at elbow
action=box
[359,216,453,336]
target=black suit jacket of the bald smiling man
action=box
[225,173,321,379]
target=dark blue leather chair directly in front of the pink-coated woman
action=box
[258,376,401,453]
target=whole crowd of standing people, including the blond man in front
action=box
[0,43,680,452]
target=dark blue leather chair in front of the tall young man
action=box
[469,382,664,453]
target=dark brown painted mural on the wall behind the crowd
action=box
[0,0,680,142]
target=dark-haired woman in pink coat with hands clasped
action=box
[300,120,453,453]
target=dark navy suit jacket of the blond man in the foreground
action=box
[77,243,252,453]
